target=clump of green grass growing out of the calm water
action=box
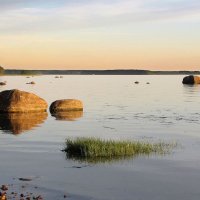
[64,138,176,162]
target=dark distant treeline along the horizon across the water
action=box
[4,69,200,75]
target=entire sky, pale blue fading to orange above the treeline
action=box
[0,0,200,70]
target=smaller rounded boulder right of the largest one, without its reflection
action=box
[49,99,83,113]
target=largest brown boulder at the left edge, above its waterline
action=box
[0,89,48,113]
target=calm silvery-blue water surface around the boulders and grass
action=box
[0,76,200,200]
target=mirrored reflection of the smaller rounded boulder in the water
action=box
[52,111,83,121]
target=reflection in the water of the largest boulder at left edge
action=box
[0,112,48,135]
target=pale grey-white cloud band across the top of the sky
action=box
[0,0,200,32]
